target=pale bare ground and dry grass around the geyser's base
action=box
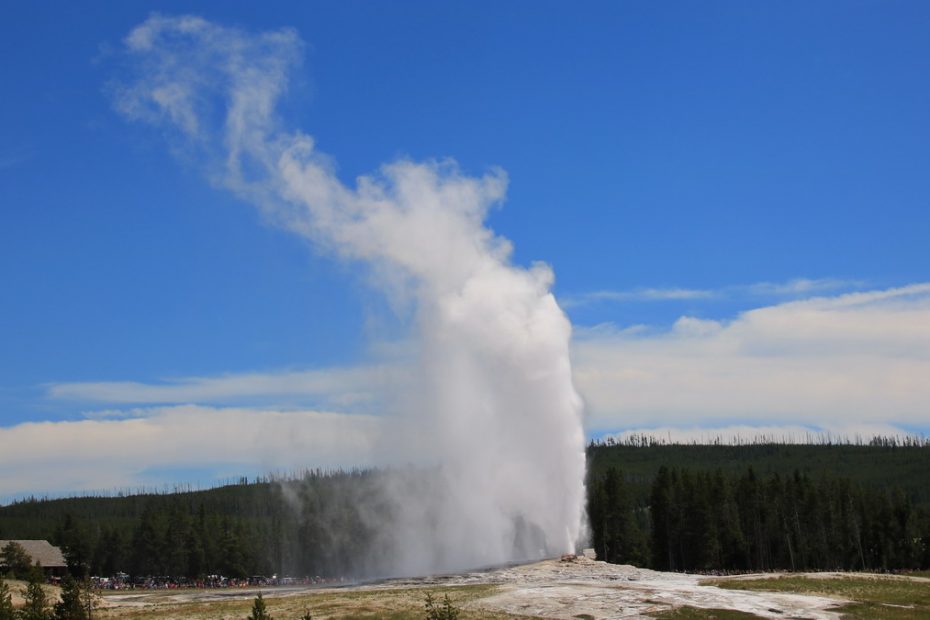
[101,557,847,620]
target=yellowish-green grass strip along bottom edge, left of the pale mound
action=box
[95,585,519,620]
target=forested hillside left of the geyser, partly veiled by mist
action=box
[0,471,389,578]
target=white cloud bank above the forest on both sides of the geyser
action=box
[0,283,930,504]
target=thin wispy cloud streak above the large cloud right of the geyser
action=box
[559,278,863,308]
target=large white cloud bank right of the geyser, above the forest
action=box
[573,284,930,431]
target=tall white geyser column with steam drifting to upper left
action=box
[112,15,585,574]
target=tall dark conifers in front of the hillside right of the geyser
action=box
[588,466,930,571]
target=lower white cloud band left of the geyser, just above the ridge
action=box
[0,405,382,497]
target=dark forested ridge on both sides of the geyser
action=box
[0,438,930,579]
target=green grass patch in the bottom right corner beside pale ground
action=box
[702,575,930,620]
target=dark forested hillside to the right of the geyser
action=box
[588,439,930,571]
